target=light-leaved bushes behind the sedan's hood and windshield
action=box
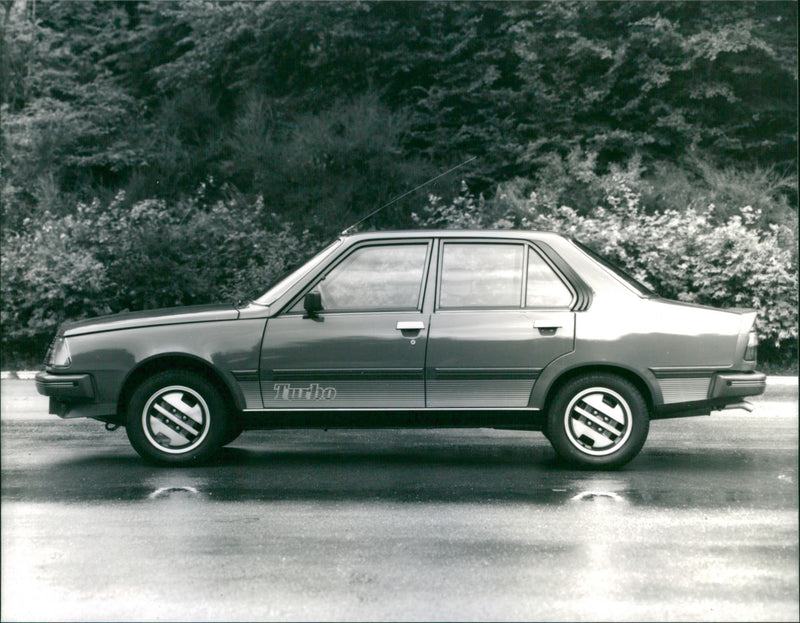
[1,187,314,365]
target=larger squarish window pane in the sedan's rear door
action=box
[439,242,525,308]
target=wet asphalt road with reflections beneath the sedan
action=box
[0,381,800,621]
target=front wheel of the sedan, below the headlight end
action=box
[126,370,229,465]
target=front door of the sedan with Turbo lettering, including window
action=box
[260,239,431,410]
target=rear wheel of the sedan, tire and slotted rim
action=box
[545,373,650,469]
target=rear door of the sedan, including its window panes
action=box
[426,239,575,408]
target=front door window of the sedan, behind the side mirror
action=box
[310,243,428,311]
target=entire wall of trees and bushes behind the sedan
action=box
[0,0,798,368]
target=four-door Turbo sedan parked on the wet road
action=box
[36,230,766,469]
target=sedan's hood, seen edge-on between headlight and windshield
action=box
[59,304,239,337]
